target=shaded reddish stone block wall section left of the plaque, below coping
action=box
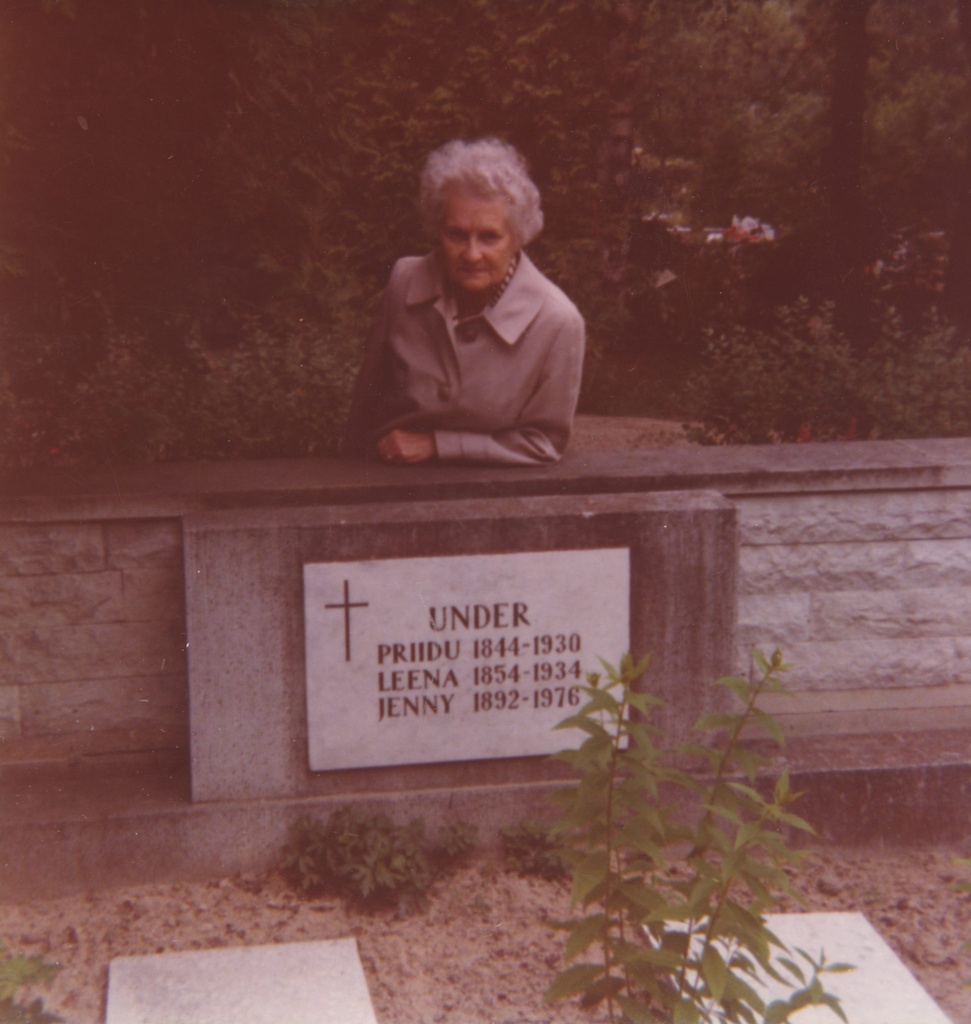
[0,519,186,762]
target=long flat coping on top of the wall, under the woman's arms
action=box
[0,438,971,522]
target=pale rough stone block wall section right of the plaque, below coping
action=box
[734,488,971,735]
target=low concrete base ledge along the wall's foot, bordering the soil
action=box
[0,730,971,903]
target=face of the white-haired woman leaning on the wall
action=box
[441,193,518,299]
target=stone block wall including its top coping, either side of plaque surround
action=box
[0,441,971,763]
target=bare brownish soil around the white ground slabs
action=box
[0,847,971,1024]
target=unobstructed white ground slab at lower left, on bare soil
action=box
[105,939,377,1024]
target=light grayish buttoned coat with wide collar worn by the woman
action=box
[344,253,584,465]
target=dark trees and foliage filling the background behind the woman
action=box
[0,0,971,463]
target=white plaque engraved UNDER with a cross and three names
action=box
[303,548,630,771]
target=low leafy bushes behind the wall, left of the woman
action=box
[0,324,354,466]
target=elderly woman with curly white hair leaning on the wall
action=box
[344,138,584,465]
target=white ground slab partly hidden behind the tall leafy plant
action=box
[766,913,952,1024]
